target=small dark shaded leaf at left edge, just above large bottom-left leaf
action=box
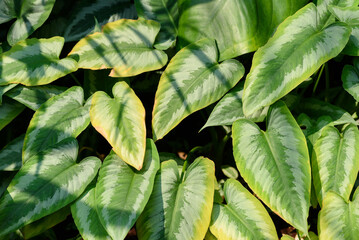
[0,134,25,171]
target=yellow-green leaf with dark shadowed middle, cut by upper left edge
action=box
[0,37,77,86]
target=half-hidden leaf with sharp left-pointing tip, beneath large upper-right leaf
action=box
[201,82,268,130]
